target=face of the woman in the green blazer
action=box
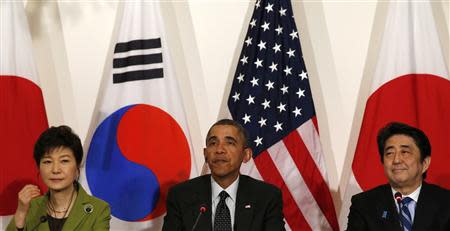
[39,147,78,191]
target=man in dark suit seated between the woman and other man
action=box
[163,119,285,231]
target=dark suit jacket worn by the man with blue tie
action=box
[347,182,450,231]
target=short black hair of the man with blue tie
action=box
[377,122,431,179]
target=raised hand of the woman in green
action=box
[14,184,41,228]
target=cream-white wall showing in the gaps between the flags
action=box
[22,0,450,211]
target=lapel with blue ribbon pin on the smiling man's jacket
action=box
[376,185,401,231]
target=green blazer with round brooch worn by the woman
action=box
[6,185,111,231]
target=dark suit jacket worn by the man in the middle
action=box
[162,175,284,231]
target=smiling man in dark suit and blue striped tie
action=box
[347,123,450,231]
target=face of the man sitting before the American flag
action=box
[203,125,251,183]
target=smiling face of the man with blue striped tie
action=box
[383,134,430,189]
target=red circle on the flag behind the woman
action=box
[0,76,48,215]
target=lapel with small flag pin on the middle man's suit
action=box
[234,176,254,231]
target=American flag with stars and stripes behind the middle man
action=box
[228,0,339,231]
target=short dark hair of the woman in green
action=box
[33,125,83,167]
